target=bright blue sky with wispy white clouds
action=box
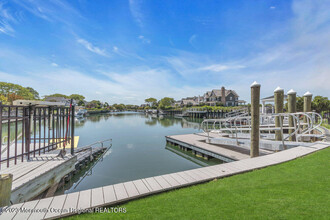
[0,0,330,104]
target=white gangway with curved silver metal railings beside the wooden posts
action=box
[201,111,325,150]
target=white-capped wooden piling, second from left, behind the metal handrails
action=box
[274,87,284,141]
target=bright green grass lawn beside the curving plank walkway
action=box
[67,148,330,219]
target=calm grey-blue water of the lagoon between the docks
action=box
[62,113,220,193]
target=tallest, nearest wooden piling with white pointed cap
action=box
[250,81,260,157]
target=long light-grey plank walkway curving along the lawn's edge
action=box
[0,142,330,220]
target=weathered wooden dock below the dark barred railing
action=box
[0,147,105,204]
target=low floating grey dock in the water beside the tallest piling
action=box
[166,133,271,162]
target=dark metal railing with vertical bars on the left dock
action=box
[0,102,74,169]
